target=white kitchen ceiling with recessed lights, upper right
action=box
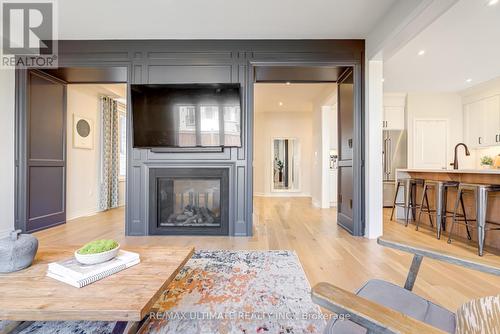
[384,0,500,92]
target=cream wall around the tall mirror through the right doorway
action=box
[253,111,312,196]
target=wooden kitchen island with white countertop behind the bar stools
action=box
[396,168,500,251]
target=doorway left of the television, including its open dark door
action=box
[16,67,127,232]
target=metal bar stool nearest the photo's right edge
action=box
[448,183,500,256]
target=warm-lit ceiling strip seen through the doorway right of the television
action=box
[254,83,337,113]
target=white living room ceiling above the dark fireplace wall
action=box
[58,0,395,39]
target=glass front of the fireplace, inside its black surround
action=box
[158,178,221,227]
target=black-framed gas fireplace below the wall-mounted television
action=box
[149,168,229,235]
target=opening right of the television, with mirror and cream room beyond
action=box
[253,83,337,201]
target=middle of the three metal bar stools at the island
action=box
[416,180,465,239]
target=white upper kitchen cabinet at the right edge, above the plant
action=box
[464,95,500,148]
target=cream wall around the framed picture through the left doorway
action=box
[66,84,125,220]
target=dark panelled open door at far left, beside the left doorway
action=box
[21,71,66,232]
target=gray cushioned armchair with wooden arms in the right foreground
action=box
[311,238,500,334]
